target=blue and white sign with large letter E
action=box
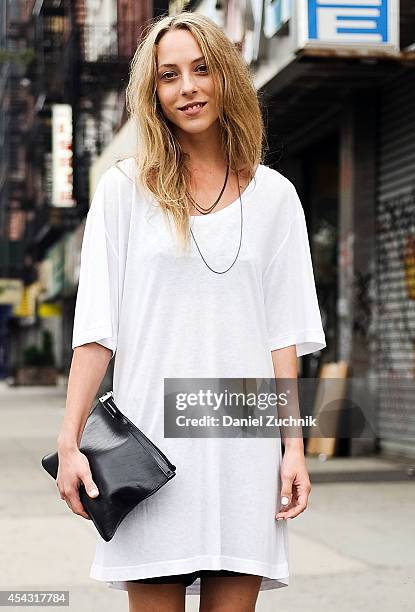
[308,0,390,44]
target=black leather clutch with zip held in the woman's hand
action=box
[42,391,176,542]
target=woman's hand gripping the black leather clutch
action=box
[56,449,99,520]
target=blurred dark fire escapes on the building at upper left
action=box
[0,0,168,277]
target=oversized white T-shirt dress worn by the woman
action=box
[72,158,326,594]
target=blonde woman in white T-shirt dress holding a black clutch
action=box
[58,12,325,612]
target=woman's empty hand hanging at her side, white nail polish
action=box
[275,448,311,520]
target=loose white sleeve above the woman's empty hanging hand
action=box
[263,188,326,357]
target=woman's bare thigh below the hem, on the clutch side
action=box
[127,581,186,612]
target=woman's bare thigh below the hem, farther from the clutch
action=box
[199,572,262,612]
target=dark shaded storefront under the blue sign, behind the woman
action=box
[242,1,415,455]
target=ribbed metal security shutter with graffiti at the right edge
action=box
[374,68,415,455]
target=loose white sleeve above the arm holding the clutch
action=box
[72,171,119,359]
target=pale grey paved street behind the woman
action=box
[0,383,415,612]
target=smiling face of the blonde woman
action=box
[157,30,218,134]
